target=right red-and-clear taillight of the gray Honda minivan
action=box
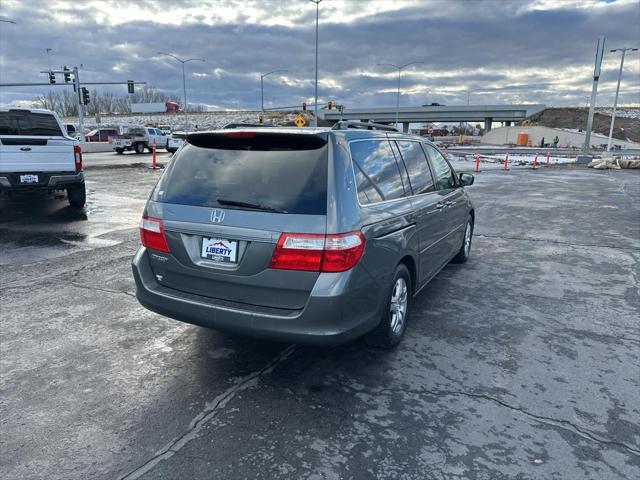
[269,232,364,272]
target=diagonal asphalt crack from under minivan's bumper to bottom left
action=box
[119,345,296,480]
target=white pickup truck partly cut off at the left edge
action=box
[0,108,86,208]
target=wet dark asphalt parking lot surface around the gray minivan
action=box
[0,154,640,479]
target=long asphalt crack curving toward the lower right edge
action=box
[341,384,640,456]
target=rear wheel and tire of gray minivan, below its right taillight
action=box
[365,264,412,349]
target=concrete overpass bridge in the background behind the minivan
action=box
[318,104,546,132]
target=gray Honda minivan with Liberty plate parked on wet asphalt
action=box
[133,122,474,347]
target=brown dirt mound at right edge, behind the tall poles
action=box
[520,108,640,142]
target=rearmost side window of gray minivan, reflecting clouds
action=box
[349,140,405,205]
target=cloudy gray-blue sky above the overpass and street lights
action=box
[0,0,640,109]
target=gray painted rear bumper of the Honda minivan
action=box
[132,247,381,346]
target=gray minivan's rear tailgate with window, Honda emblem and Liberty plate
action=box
[146,131,328,310]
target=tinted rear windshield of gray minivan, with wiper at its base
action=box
[152,140,327,215]
